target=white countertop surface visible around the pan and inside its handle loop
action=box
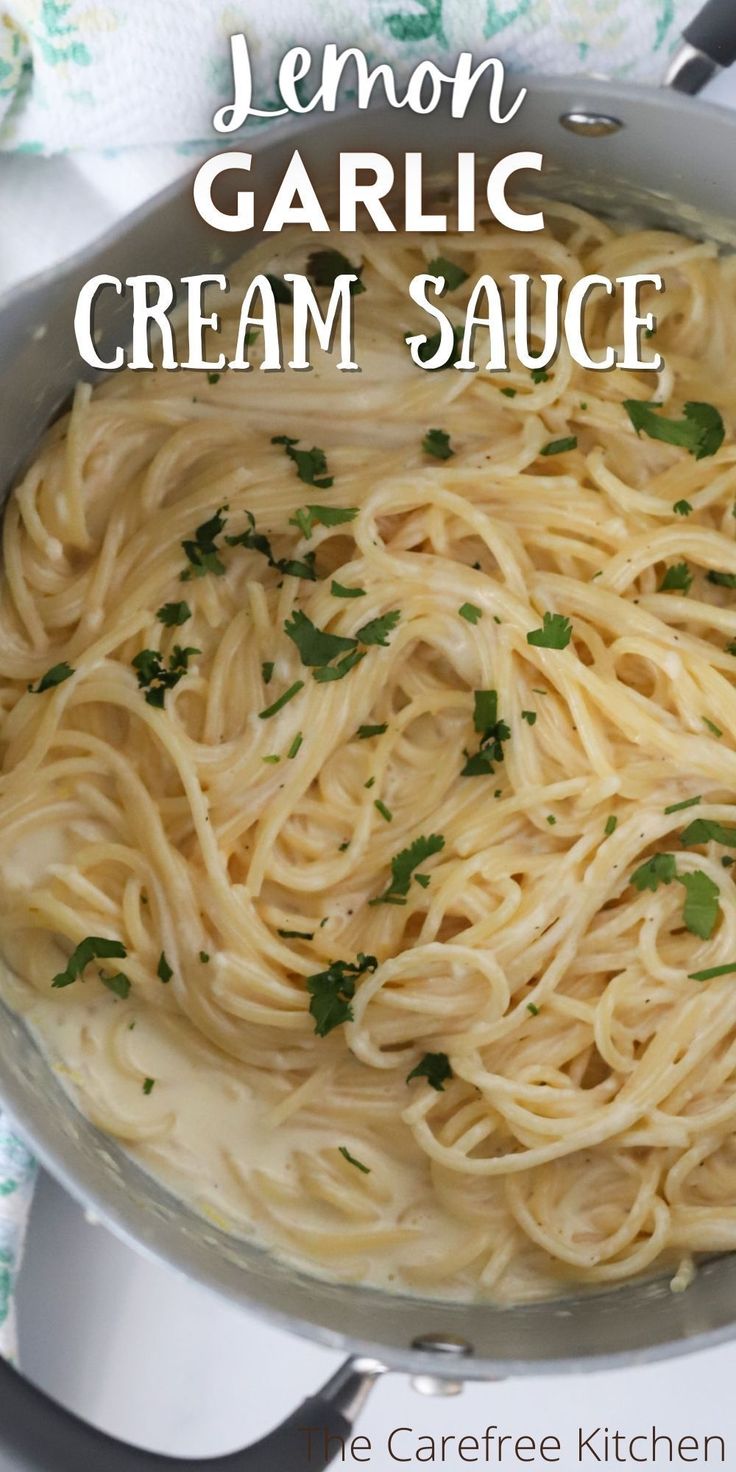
[7,77,736,1472]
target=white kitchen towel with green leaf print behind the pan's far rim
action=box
[0,0,699,153]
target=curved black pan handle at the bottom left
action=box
[0,1359,386,1472]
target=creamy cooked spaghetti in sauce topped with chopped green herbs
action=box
[0,206,736,1301]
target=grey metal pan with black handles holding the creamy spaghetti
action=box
[0,0,736,1472]
